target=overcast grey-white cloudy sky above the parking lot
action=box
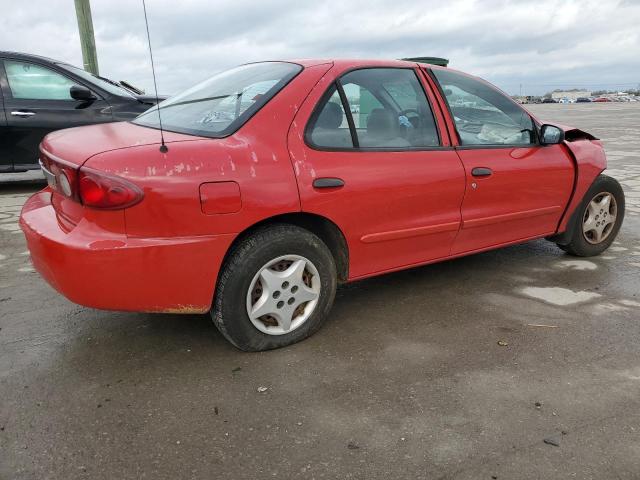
[0,0,640,94]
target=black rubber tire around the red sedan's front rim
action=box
[558,175,625,257]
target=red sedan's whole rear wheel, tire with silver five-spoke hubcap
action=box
[211,225,337,351]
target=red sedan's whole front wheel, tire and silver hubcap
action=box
[561,175,625,257]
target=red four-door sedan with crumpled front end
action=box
[20,60,624,350]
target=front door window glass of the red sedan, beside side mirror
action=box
[432,69,535,145]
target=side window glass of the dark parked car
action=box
[4,60,74,100]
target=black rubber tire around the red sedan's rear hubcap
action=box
[211,224,337,352]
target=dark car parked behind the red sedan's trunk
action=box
[0,51,165,172]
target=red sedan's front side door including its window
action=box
[432,69,574,254]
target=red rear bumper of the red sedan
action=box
[20,189,233,313]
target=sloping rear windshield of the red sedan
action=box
[133,62,302,138]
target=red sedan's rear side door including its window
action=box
[289,67,464,278]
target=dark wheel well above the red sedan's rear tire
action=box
[225,212,349,282]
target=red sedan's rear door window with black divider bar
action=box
[307,68,440,150]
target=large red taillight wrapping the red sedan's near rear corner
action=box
[78,167,143,210]
